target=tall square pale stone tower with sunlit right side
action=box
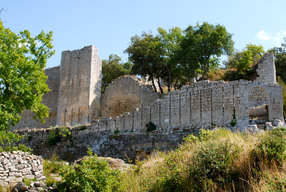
[57,45,102,126]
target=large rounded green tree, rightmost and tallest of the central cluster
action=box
[178,22,234,80]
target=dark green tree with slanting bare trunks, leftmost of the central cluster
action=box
[124,32,164,93]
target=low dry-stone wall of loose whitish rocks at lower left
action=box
[0,151,46,186]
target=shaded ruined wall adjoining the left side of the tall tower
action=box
[11,66,60,130]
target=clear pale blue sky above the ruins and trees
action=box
[0,0,286,67]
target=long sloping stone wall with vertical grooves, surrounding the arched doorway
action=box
[95,80,283,131]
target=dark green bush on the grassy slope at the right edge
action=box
[252,127,286,167]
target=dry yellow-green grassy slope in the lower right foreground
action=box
[120,129,286,192]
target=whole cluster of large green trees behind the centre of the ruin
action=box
[125,22,233,93]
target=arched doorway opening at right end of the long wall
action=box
[248,87,269,128]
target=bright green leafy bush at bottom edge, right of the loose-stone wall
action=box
[58,149,121,191]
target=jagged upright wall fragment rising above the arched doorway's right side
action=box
[255,52,276,83]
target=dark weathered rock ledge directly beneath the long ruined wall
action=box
[19,125,192,162]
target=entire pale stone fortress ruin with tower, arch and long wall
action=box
[11,46,284,133]
